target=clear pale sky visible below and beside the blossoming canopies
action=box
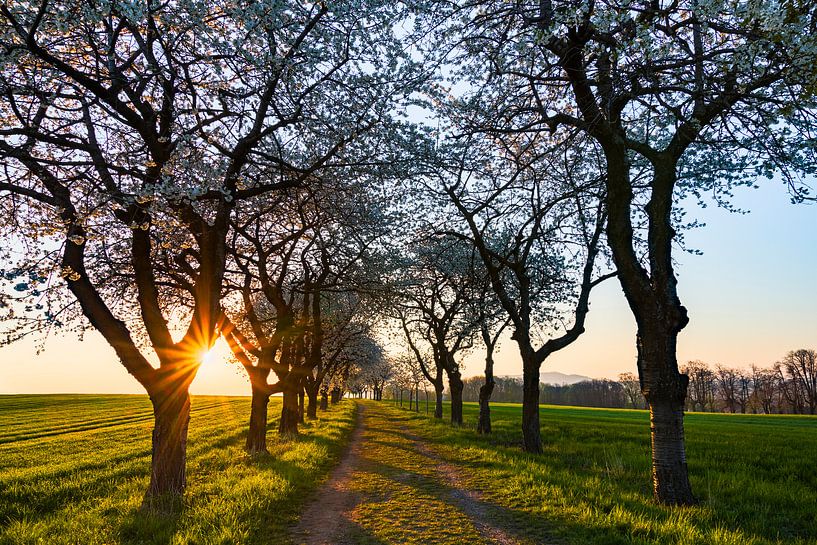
[0,182,817,395]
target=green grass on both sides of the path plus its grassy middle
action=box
[0,395,817,545]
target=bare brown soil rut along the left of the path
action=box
[292,404,366,545]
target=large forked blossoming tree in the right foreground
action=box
[426,0,817,504]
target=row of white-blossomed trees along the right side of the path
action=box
[392,0,817,504]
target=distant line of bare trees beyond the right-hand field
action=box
[463,349,817,414]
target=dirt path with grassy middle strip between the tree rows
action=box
[292,402,534,545]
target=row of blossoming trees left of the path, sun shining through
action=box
[0,0,417,504]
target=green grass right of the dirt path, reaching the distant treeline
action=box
[391,404,817,545]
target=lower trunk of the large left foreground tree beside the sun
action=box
[145,388,190,504]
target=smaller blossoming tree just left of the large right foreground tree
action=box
[431,129,611,452]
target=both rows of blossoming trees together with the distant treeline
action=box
[0,0,817,505]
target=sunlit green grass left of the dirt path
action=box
[0,395,355,545]
